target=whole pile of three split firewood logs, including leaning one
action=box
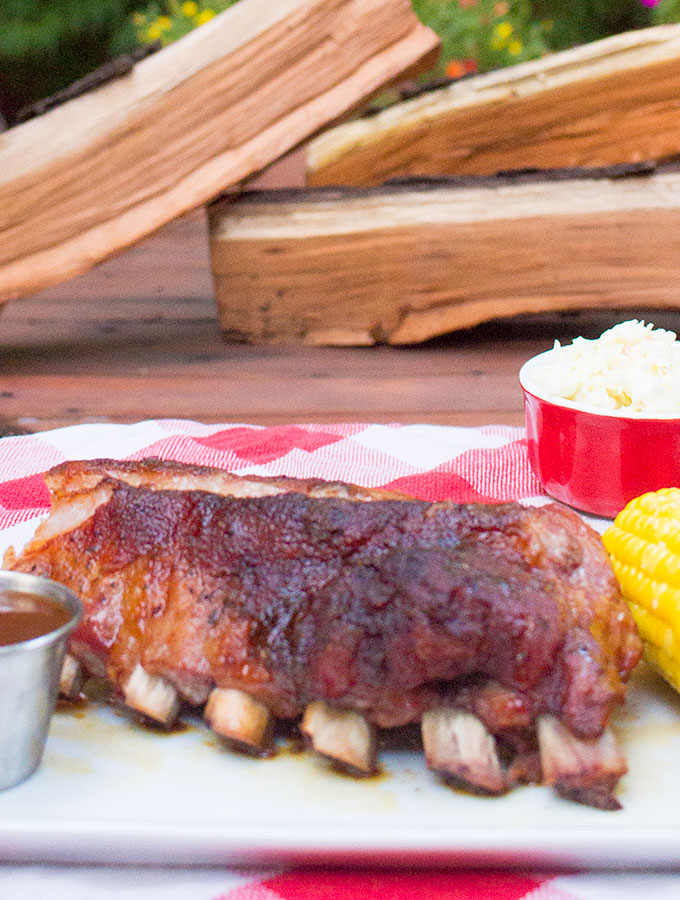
[0,0,680,344]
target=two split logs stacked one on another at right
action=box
[210,25,680,344]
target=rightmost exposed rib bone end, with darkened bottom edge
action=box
[538,716,628,809]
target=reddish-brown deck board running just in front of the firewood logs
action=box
[0,328,540,378]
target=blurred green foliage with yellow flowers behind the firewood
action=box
[0,0,680,120]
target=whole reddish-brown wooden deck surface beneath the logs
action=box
[0,214,680,433]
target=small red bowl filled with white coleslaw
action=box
[519,321,680,518]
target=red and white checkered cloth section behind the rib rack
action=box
[0,420,540,529]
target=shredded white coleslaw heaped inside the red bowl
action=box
[533,319,680,417]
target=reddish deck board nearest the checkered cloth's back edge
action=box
[0,374,521,427]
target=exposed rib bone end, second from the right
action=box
[422,707,507,794]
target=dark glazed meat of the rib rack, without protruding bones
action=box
[14,472,640,738]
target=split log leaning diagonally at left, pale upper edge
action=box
[0,0,437,301]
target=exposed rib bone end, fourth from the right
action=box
[205,688,272,754]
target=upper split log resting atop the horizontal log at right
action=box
[306,25,680,186]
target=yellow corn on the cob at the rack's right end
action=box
[602,488,680,691]
